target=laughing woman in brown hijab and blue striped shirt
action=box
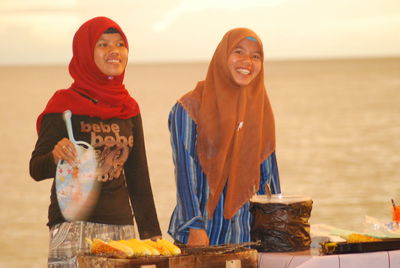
[168,28,280,246]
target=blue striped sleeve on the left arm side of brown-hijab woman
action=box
[168,103,207,242]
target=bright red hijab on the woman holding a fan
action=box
[36,17,139,133]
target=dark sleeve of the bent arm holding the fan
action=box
[29,114,67,181]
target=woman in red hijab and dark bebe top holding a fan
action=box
[30,17,161,267]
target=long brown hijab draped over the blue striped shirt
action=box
[179,28,275,219]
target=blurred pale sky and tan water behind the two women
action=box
[0,0,400,267]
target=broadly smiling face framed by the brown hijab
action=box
[228,38,262,87]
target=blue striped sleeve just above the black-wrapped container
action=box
[257,152,281,194]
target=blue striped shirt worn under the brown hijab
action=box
[168,103,280,245]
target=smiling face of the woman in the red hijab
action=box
[94,33,128,76]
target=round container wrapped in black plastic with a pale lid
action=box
[250,194,313,252]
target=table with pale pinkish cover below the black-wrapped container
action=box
[258,249,400,268]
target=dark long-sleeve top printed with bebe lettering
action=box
[30,113,161,239]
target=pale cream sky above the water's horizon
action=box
[0,0,400,65]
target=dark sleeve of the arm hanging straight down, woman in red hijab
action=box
[124,114,161,239]
